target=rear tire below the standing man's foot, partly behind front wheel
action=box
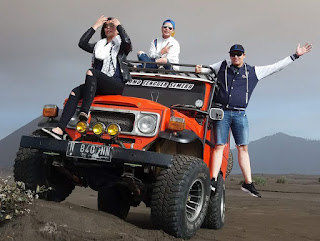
[202,174,226,229]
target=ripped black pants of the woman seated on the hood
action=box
[58,69,124,131]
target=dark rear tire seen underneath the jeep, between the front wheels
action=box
[98,185,131,219]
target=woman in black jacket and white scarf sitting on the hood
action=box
[42,16,132,139]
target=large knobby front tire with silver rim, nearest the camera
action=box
[151,155,210,239]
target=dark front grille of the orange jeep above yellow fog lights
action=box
[89,111,135,132]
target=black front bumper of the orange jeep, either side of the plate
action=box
[20,136,173,168]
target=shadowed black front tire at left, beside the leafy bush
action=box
[13,130,75,202]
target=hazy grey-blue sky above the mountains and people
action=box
[0,0,320,141]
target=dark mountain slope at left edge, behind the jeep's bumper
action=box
[0,116,43,170]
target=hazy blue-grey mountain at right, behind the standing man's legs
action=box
[232,133,320,175]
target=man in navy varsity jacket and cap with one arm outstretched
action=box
[195,43,312,197]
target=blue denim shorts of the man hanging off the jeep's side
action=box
[213,110,249,146]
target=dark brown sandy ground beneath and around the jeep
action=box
[0,175,320,241]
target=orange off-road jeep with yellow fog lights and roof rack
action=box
[14,61,233,238]
